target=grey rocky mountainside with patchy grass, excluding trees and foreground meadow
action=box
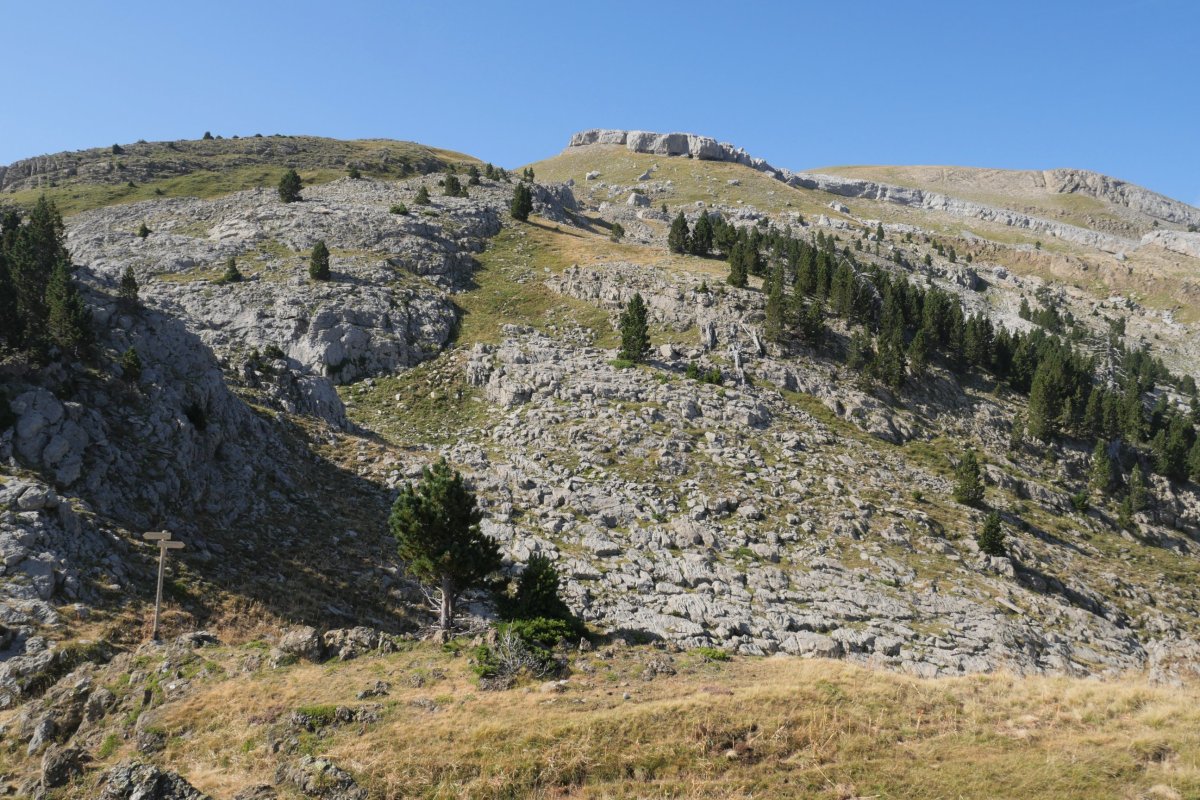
[0,131,1200,798]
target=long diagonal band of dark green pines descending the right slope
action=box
[667,212,1200,489]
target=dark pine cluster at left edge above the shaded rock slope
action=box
[0,197,91,359]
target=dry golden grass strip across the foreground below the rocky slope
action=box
[77,644,1200,800]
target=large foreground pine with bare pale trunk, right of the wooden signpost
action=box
[388,459,500,632]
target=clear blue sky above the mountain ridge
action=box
[0,0,1200,204]
